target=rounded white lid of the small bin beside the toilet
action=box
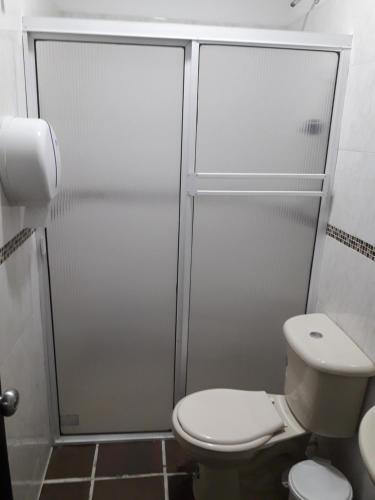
[289,460,353,500]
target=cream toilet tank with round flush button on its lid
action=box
[283,314,375,438]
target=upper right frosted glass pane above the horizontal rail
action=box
[196,46,338,173]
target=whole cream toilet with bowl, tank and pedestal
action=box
[172,314,375,500]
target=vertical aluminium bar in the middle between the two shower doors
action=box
[174,41,199,403]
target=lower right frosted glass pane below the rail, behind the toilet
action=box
[187,197,319,393]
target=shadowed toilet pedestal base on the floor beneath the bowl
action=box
[193,464,241,500]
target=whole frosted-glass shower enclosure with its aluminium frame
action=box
[24,19,350,440]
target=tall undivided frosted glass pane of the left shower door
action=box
[37,41,184,433]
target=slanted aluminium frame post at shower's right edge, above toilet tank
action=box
[306,49,350,313]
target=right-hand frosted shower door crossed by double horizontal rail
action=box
[187,45,338,392]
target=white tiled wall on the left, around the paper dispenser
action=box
[0,0,59,500]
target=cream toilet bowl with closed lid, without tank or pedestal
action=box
[172,389,307,467]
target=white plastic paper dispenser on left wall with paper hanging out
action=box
[0,116,61,228]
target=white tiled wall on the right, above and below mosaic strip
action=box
[306,0,375,500]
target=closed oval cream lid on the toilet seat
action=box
[177,389,284,445]
